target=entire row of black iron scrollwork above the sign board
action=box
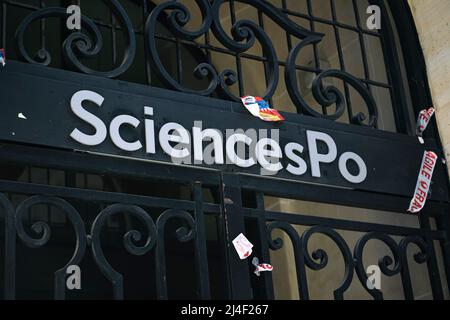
[16,0,378,127]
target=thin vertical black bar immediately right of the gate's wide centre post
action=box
[256,192,274,300]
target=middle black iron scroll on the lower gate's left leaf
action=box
[91,204,156,300]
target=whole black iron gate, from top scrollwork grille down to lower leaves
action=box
[0,0,450,299]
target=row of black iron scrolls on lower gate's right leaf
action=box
[267,221,431,300]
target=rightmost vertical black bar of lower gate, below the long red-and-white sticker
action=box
[419,212,444,300]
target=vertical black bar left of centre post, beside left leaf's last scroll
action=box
[193,182,211,300]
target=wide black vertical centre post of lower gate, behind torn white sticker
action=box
[221,173,253,300]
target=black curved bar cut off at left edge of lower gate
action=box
[0,193,16,300]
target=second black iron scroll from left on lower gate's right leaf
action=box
[302,226,353,300]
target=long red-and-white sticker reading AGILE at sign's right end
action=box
[408,151,438,213]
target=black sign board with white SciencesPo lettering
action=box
[0,62,448,200]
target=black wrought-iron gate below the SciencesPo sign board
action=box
[0,144,449,299]
